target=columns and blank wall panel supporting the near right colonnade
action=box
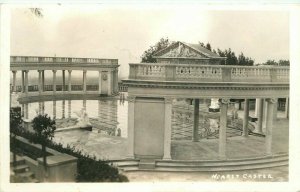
[127,96,288,160]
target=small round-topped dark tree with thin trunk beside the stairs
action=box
[32,114,56,170]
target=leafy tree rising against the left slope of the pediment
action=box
[141,38,171,63]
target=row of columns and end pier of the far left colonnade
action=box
[12,68,118,95]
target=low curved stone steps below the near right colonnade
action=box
[117,154,289,172]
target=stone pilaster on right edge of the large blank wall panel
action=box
[163,98,173,160]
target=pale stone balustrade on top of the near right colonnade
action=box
[129,63,290,82]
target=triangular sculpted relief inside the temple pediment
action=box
[161,43,203,58]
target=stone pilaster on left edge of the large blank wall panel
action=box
[127,95,135,158]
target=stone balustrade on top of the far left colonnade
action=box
[10,56,118,65]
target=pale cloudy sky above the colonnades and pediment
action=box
[11,5,289,77]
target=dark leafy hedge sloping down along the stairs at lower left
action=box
[12,130,128,182]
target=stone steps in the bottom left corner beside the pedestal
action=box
[10,153,39,183]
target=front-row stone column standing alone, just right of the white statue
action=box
[219,99,230,159]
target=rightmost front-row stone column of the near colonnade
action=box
[266,98,276,155]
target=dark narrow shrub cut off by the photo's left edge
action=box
[10,107,22,166]
